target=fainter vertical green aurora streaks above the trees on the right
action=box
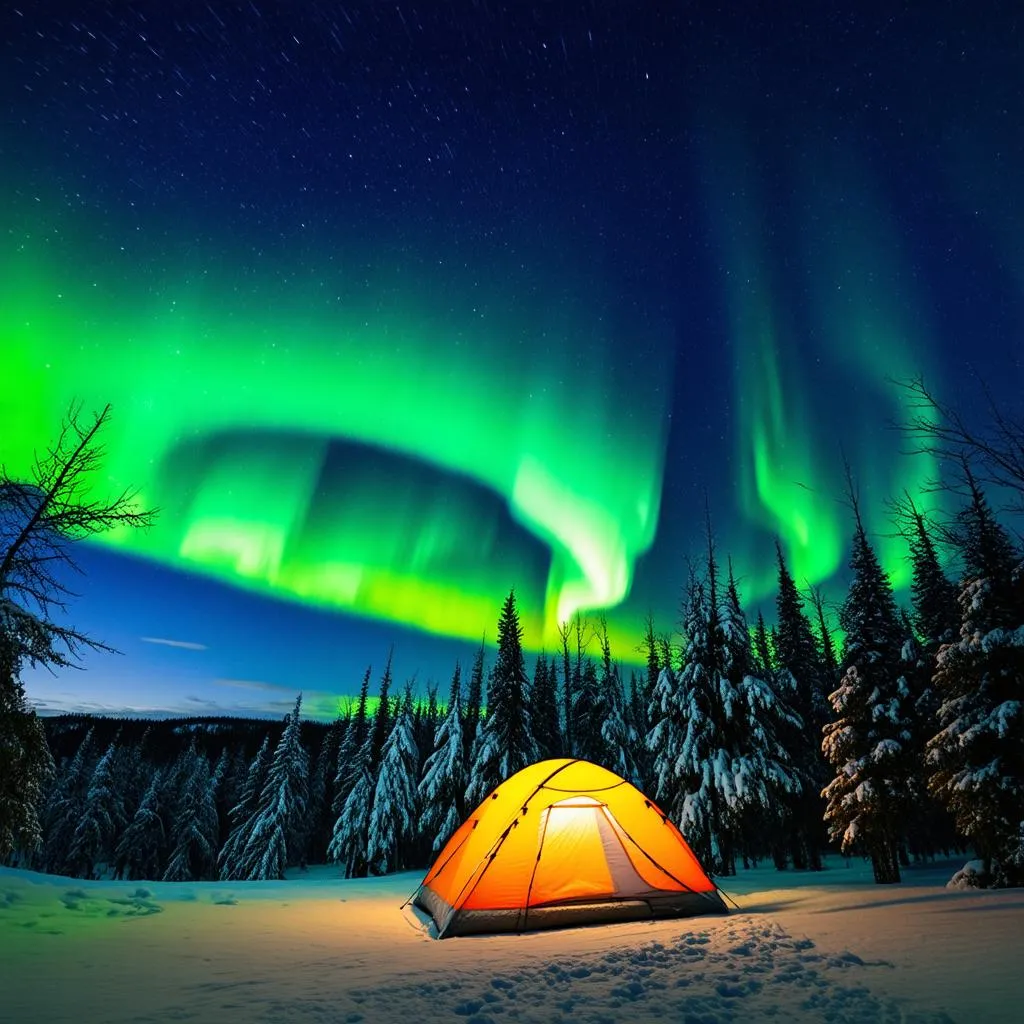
[705,118,939,602]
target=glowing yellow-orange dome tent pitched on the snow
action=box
[413,758,727,938]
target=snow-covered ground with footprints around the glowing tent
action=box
[0,859,1024,1024]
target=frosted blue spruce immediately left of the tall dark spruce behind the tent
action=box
[419,665,467,853]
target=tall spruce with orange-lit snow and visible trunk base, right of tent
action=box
[822,499,914,883]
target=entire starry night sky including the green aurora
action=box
[0,0,1024,717]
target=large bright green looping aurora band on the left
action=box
[0,203,669,648]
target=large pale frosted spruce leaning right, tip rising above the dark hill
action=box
[239,693,309,881]
